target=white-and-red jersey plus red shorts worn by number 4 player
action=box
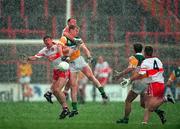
[139,53,165,98]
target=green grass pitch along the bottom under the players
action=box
[0,102,180,129]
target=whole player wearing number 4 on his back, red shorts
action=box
[130,46,175,124]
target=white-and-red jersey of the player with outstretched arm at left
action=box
[35,44,62,68]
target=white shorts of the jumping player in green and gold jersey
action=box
[69,56,88,72]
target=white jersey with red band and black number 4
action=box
[139,57,164,83]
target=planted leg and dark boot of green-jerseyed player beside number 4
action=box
[116,90,138,124]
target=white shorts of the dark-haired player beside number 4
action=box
[131,80,148,94]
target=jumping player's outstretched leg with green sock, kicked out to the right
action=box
[82,66,108,101]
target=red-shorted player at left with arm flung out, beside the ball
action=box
[28,36,70,119]
